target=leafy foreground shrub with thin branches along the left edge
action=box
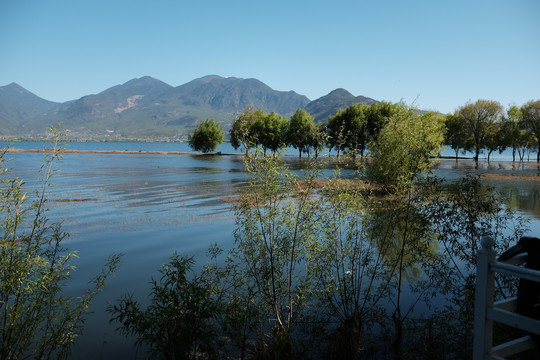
[0,130,120,359]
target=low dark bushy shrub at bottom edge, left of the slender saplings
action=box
[107,254,220,359]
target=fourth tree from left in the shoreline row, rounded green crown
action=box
[287,109,317,158]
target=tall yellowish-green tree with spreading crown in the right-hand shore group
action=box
[457,100,503,161]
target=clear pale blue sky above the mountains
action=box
[0,0,540,112]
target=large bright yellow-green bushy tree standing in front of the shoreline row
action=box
[368,106,444,190]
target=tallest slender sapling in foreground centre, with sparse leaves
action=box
[231,156,314,358]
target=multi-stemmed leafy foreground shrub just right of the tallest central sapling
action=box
[306,179,392,359]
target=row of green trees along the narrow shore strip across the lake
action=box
[189,100,540,161]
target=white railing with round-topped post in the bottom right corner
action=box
[473,237,540,360]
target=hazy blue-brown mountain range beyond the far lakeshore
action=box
[0,75,376,140]
